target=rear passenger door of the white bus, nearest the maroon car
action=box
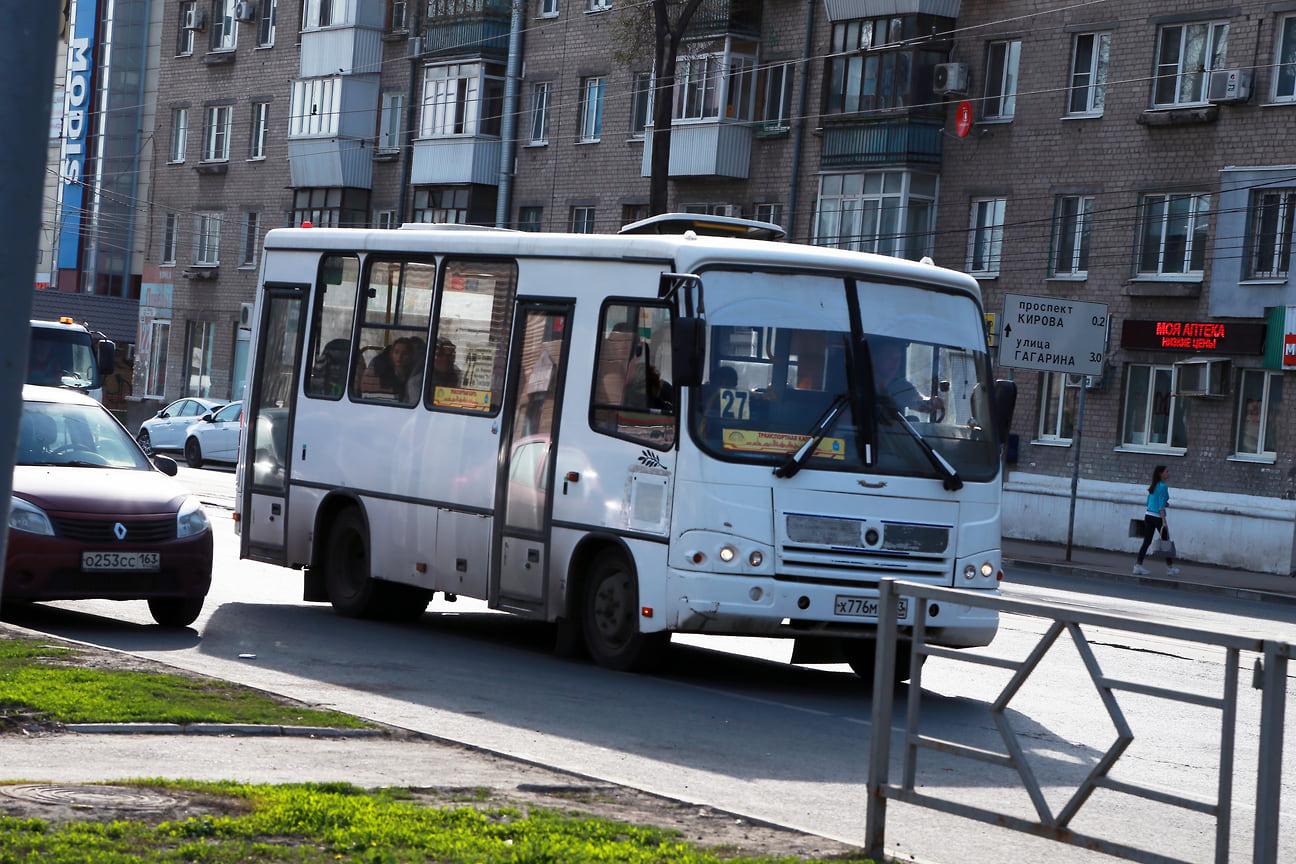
[240,282,311,563]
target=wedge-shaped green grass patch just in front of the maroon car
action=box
[0,639,372,730]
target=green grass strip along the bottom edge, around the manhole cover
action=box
[0,780,867,864]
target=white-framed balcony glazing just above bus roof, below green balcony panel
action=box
[814,171,936,260]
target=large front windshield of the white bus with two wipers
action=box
[689,272,999,481]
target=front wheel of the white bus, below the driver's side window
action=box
[582,552,670,672]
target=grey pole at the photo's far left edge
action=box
[0,3,58,606]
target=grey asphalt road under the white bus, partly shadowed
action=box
[6,468,1296,863]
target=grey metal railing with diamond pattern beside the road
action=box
[864,579,1292,864]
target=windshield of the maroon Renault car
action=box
[17,402,150,470]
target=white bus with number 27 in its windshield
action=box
[235,215,1015,676]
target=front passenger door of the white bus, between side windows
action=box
[489,301,572,617]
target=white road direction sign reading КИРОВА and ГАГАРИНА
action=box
[999,294,1107,376]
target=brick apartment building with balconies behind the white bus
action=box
[137,0,1296,573]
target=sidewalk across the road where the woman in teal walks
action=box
[1003,538,1296,605]
